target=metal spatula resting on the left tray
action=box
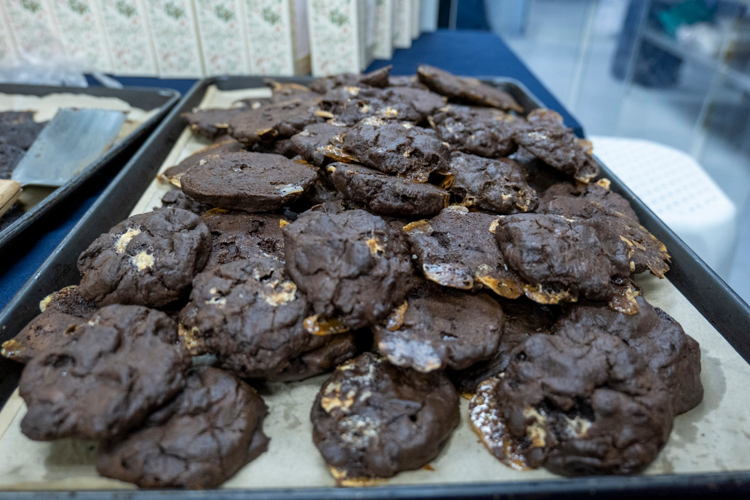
[0,109,126,216]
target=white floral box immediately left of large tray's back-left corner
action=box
[144,0,204,78]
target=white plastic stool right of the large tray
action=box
[589,136,737,279]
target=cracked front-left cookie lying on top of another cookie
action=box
[20,305,190,441]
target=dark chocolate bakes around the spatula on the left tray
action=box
[0,111,46,231]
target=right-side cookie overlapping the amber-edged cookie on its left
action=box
[492,214,638,313]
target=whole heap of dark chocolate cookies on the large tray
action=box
[3,66,703,488]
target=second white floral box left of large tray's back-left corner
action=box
[98,0,158,75]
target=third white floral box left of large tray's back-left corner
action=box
[48,0,112,72]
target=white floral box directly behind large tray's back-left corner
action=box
[195,0,251,76]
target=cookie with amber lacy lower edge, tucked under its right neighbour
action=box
[404,206,523,299]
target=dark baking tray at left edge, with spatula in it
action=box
[0,84,180,254]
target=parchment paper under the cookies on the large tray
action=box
[0,89,750,490]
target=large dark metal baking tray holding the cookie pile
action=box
[0,77,750,500]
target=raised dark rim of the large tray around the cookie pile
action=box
[0,76,750,500]
